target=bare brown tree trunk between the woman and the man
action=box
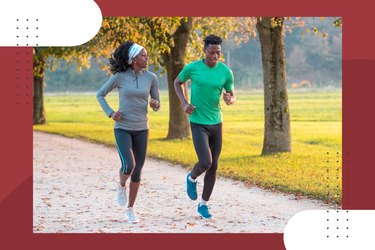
[163,17,192,139]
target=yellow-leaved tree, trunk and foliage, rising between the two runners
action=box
[143,17,255,139]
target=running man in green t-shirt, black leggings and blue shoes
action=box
[174,35,236,219]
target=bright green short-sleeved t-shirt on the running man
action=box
[178,59,233,125]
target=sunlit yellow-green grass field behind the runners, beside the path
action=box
[34,91,342,204]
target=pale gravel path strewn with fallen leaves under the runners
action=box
[33,132,332,233]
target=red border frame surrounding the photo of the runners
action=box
[0,0,375,250]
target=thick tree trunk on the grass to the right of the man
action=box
[256,17,292,155]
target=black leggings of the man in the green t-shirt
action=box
[190,123,223,201]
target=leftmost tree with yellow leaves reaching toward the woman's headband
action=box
[33,18,154,124]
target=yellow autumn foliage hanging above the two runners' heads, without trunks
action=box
[39,17,262,76]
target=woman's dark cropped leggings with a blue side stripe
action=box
[115,128,148,182]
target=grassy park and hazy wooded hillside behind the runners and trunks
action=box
[34,18,342,204]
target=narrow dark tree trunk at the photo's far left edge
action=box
[33,48,46,124]
